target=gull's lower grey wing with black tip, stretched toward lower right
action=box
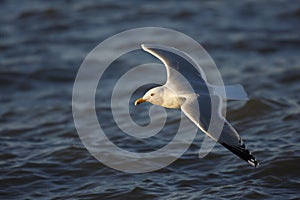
[181,95,258,167]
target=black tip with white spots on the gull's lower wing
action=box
[221,143,259,167]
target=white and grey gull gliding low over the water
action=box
[135,44,259,167]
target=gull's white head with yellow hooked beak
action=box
[134,86,164,105]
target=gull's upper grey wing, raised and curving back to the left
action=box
[142,44,209,95]
